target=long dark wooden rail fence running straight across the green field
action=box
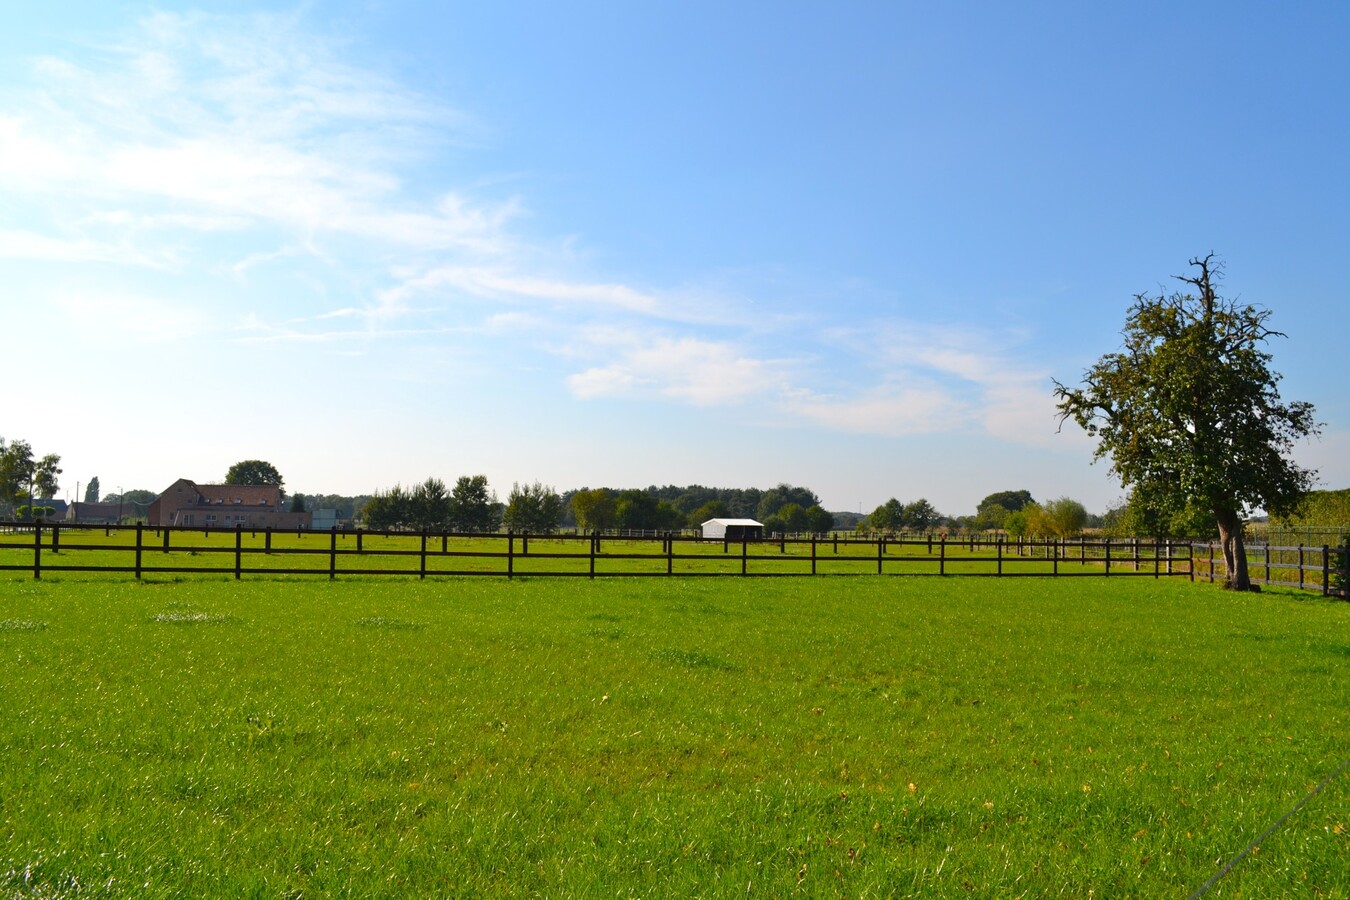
[0,524,1196,580]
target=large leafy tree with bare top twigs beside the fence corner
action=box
[1054,254,1319,591]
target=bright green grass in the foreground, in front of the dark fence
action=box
[0,576,1350,897]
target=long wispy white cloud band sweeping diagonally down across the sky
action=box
[0,13,1074,450]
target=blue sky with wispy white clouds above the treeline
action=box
[0,0,1350,514]
